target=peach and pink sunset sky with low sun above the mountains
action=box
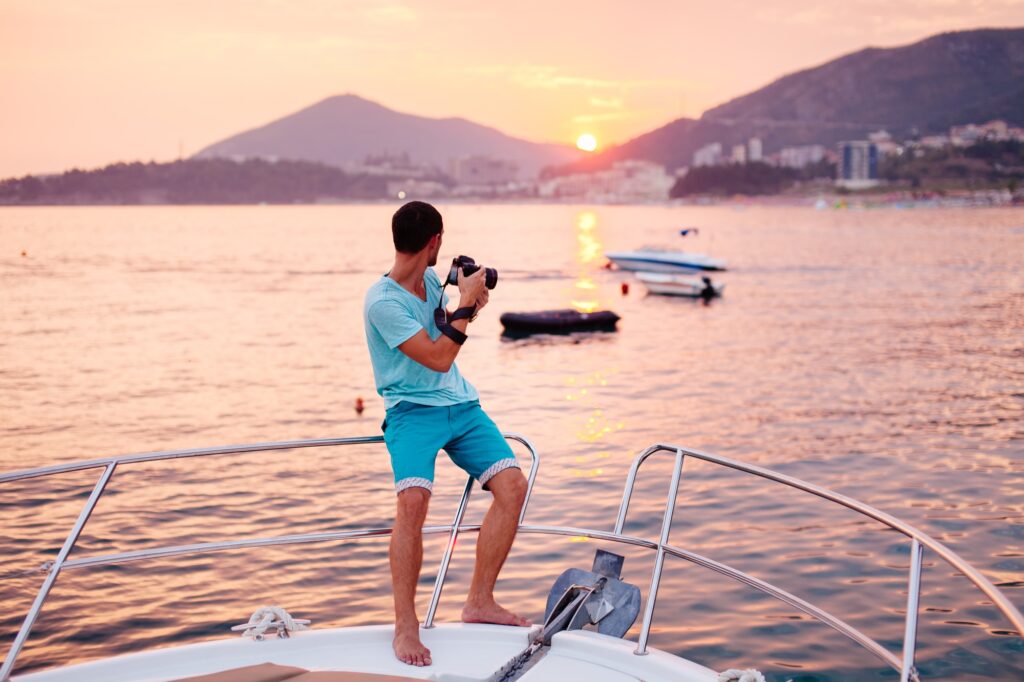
[0,0,1024,177]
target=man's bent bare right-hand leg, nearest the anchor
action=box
[462,468,529,626]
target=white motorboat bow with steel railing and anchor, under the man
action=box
[0,434,1024,682]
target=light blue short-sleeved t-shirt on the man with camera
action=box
[362,267,479,408]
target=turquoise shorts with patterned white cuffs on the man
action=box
[381,400,519,493]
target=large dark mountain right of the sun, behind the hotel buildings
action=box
[551,29,1024,174]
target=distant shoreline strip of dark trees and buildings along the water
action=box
[0,159,1024,208]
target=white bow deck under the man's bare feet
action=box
[13,624,718,682]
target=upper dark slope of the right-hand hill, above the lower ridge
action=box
[702,29,1024,135]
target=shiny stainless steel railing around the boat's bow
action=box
[0,434,1024,682]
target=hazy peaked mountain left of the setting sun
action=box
[196,94,580,178]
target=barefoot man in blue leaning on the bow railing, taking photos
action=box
[364,202,529,666]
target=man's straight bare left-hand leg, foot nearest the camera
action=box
[389,487,431,666]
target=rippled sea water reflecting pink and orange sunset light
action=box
[0,204,1024,680]
